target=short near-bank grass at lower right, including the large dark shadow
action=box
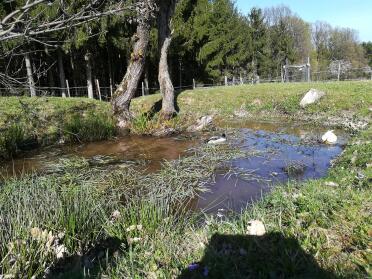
[104,129,372,278]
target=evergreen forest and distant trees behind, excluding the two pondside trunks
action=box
[0,0,371,93]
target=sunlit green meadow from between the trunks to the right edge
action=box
[132,81,372,133]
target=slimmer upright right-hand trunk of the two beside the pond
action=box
[158,0,177,119]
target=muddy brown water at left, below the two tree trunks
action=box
[0,136,195,177]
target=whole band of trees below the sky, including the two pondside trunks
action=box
[0,0,372,128]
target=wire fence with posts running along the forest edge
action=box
[0,68,372,101]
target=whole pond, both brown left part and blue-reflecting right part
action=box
[0,121,348,213]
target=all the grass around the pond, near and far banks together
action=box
[0,82,372,278]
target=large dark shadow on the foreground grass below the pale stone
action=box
[178,233,335,279]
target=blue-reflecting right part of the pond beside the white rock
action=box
[194,122,347,213]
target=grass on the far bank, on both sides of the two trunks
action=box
[0,81,372,158]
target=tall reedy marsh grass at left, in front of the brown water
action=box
[0,143,246,278]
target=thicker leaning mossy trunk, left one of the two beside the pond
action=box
[111,20,150,133]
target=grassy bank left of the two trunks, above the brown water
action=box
[0,97,116,158]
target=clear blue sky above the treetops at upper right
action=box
[236,0,372,41]
